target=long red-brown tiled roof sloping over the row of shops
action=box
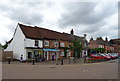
[19,24,83,41]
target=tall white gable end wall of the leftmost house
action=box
[5,25,26,60]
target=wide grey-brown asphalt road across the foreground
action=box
[2,62,118,79]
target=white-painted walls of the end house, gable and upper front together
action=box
[5,25,43,60]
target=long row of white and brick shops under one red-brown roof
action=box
[5,24,87,60]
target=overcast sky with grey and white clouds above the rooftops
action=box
[0,0,118,44]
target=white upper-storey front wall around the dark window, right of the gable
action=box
[25,38,43,48]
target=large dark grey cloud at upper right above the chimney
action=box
[59,2,116,26]
